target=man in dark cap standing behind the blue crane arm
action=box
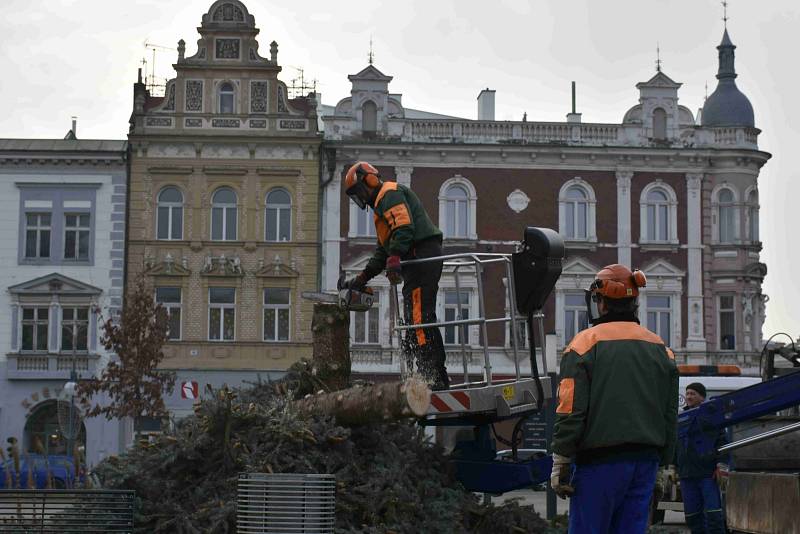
[677,382,728,534]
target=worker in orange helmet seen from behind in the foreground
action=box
[550,264,678,534]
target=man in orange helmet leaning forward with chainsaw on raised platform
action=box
[345,161,450,390]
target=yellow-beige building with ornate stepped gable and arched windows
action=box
[127,0,321,413]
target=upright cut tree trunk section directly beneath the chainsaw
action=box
[311,302,350,391]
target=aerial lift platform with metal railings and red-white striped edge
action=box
[390,227,564,494]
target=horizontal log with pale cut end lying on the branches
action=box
[295,378,431,426]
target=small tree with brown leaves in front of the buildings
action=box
[77,276,175,419]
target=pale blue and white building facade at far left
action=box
[0,136,130,465]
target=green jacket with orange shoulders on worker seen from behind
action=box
[552,321,678,465]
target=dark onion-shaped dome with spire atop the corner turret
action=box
[701,29,755,128]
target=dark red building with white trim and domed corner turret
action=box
[322,27,770,373]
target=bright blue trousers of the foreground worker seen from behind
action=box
[569,460,658,534]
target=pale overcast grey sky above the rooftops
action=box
[0,0,800,337]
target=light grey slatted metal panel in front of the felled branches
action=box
[236,473,336,534]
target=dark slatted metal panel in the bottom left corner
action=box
[0,489,134,534]
